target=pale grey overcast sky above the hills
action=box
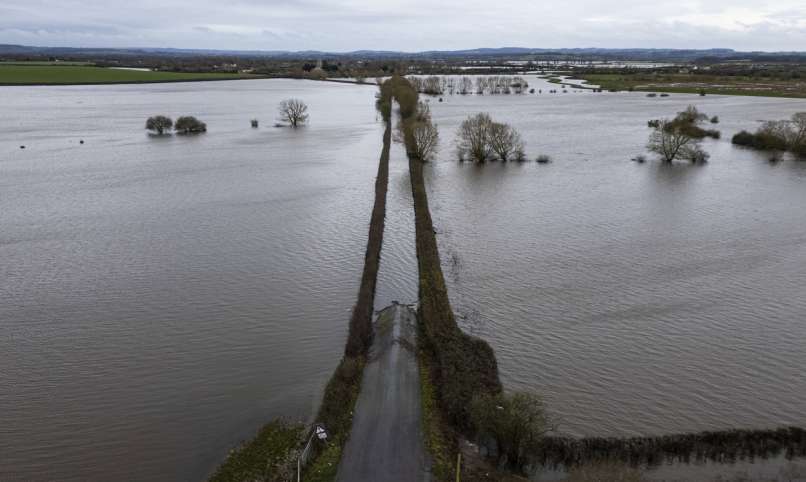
[0,0,806,51]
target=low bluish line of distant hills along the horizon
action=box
[0,44,806,62]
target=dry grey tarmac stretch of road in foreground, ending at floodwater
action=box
[336,303,431,482]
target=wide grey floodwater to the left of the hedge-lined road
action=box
[0,80,386,481]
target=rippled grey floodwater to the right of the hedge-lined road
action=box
[426,74,806,436]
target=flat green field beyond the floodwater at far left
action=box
[0,63,255,85]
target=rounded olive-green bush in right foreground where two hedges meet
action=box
[470,392,552,470]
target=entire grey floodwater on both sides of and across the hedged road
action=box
[0,78,806,481]
